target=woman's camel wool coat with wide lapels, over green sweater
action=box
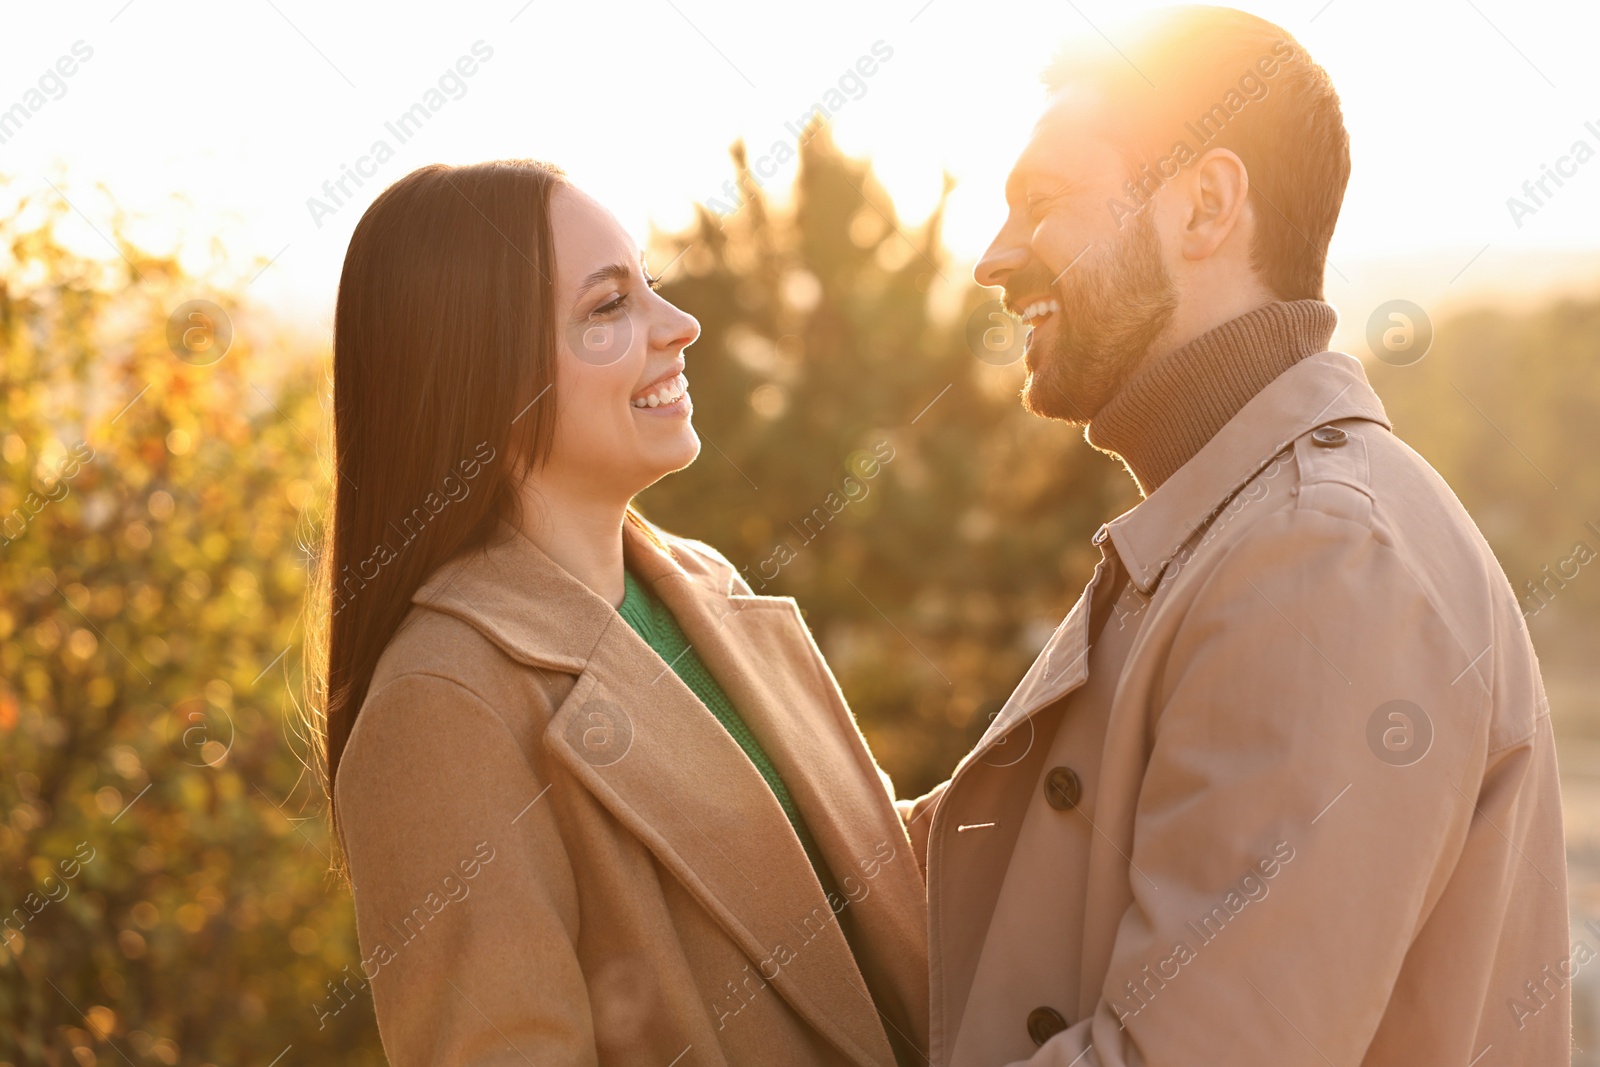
[334,523,928,1067]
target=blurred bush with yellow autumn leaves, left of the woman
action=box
[0,187,382,1064]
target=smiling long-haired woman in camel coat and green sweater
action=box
[304,160,928,1067]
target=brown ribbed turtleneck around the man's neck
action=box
[1083,301,1339,496]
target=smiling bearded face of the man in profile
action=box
[973,85,1178,424]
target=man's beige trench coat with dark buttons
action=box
[906,354,1576,1067]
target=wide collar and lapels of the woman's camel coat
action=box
[413,522,926,1067]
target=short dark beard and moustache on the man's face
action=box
[1006,204,1178,426]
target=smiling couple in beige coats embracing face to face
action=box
[322,8,1571,1067]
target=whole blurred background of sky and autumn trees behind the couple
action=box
[0,0,1600,1067]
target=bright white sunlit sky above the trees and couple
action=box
[0,0,1600,334]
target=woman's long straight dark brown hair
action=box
[306,160,566,825]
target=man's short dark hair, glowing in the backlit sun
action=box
[1043,6,1350,301]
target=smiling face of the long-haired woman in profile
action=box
[539,186,699,502]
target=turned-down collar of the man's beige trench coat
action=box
[1104,352,1390,595]
